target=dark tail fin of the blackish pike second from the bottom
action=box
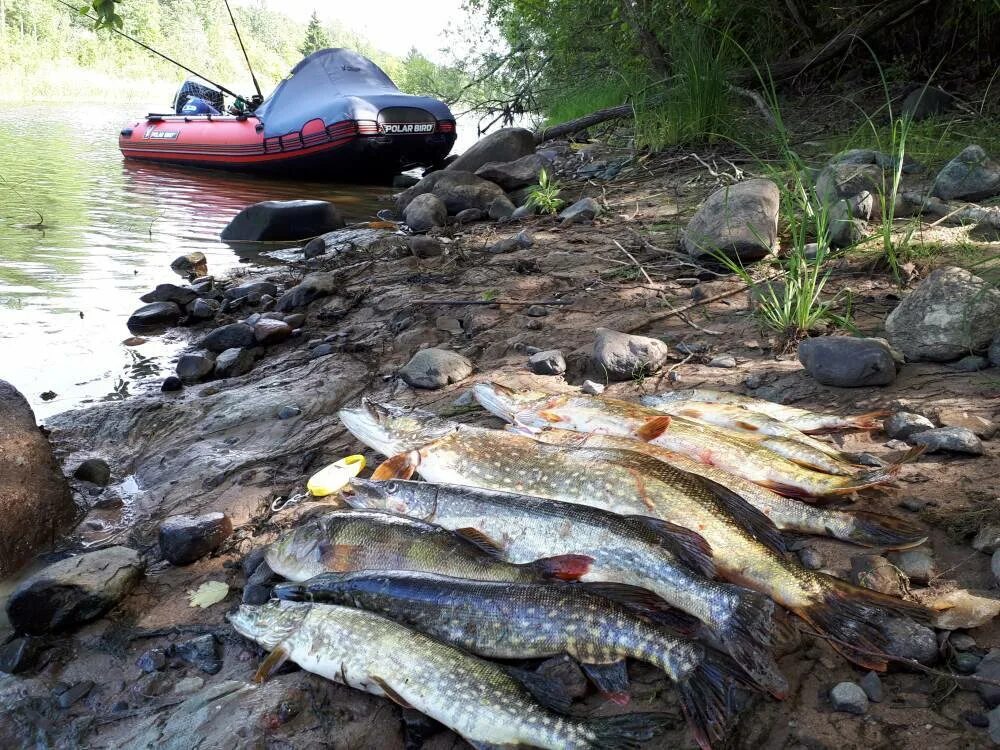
[677,650,756,750]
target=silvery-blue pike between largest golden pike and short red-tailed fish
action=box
[344,479,788,697]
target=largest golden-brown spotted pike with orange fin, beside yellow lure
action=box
[340,403,929,670]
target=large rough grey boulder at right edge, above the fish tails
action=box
[885,267,1000,362]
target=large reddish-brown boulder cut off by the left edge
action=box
[0,380,77,579]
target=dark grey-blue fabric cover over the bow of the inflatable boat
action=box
[254,48,454,138]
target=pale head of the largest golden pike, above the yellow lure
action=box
[337,399,454,456]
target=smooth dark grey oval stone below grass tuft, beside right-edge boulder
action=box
[799,336,896,388]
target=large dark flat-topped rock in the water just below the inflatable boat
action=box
[219,200,344,242]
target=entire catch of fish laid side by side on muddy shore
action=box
[230,383,929,748]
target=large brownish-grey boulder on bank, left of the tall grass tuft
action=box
[681,180,781,261]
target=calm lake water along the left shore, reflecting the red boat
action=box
[0,104,466,419]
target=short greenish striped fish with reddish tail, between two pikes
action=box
[265,510,591,582]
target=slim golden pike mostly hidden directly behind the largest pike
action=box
[520,428,927,549]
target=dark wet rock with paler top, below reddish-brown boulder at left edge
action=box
[7,547,143,635]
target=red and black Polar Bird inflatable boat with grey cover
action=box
[118,49,455,182]
